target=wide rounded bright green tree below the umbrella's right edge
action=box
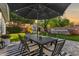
[47,17,70,27]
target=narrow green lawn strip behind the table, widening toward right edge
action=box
[42,33,79,41]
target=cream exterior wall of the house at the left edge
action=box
[0,3,10,34]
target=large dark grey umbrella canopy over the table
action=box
[8,3,70,20]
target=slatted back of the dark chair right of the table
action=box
[52,40,65,56]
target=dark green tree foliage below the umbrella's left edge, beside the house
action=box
[10,12,34,24]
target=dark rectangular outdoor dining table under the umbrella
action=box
[30,36,57,56]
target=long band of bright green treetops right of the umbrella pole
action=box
[39,17,71,28]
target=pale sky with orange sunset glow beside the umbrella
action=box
[64,3,79,25]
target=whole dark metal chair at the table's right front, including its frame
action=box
[44,40,65,56]
